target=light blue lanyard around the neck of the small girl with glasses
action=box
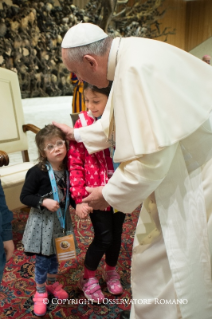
[46,163,69,231]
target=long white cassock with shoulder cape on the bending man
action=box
[73,38,212,319]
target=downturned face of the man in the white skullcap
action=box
[62,50,109,88]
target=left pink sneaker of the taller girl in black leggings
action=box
[79,276,105,303]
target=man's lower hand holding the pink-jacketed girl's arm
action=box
[82,186,110,210]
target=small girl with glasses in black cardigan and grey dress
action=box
[20,125,73,316]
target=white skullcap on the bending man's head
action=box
[61,23,108,49]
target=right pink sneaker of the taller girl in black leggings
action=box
[102,269,123,295]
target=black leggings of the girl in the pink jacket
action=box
[85,209,125,270]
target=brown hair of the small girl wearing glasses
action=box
[35,124,68,171]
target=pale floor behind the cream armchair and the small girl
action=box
[10,96,72,165]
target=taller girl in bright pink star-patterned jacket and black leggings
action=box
[68,83,125,303]
